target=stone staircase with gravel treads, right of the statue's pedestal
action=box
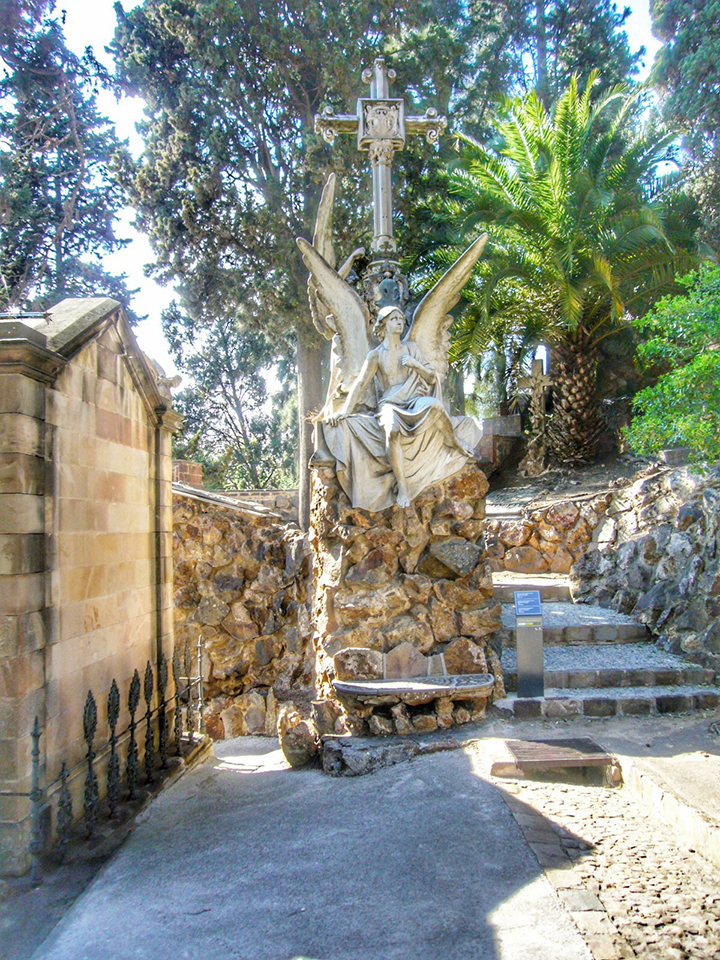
[493,572,720,720]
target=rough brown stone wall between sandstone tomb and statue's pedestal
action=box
[173,493,312,739]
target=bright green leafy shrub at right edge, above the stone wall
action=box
[626,266,720,461]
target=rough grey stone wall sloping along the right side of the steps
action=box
[571,467,720,669]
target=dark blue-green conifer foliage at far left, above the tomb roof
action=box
[0,2,138,309]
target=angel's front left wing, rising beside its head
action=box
[297,237,371,409]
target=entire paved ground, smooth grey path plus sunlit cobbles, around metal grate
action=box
[18,714,720,960]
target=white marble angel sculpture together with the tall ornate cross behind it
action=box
[297,57,487,512]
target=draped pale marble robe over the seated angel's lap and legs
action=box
[318,341,482,513]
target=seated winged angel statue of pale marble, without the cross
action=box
[297,176,487,513]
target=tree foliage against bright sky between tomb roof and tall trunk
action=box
[163,306,297,490]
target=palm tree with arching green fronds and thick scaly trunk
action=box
[443,72,692,462]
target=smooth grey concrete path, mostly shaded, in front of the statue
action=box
[34,738,590,960]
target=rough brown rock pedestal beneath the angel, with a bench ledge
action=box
[310,467,502,734]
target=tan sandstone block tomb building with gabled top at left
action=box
[0,298,177,873]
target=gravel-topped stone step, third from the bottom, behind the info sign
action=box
[502,602,650,648]
